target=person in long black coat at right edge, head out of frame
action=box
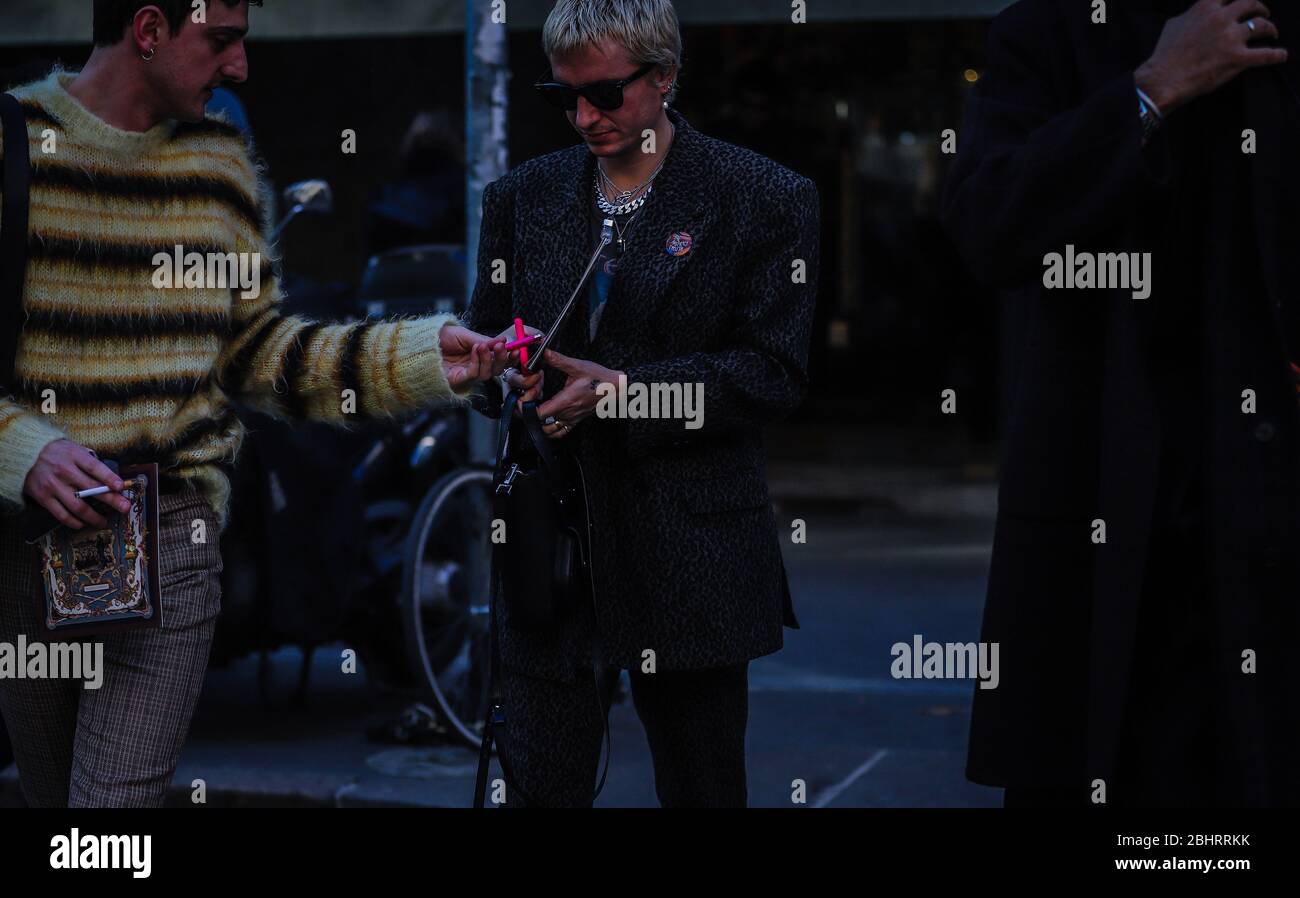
[944,0,1300,806]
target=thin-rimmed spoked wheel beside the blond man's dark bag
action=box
[402,468,493,747]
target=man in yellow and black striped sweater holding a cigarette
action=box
[0,0,508,806]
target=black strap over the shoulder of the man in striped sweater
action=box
[0,94,31,391]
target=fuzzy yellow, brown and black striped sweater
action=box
[0,70,462,526]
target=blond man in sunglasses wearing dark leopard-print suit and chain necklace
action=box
[467,0,819,806]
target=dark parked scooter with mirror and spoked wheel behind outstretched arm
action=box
[212,182,491,745]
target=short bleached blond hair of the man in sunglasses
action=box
[542,0,681,101]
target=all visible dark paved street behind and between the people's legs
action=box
[0,508,1000,807]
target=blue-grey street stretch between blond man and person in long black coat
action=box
[750,517,1000,807]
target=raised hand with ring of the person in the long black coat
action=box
[1136,0,1287,116]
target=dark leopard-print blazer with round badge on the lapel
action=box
[467,108,820,681]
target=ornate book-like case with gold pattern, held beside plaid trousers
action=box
[38,464,163,638]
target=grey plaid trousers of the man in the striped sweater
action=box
[0,487,221,807]
